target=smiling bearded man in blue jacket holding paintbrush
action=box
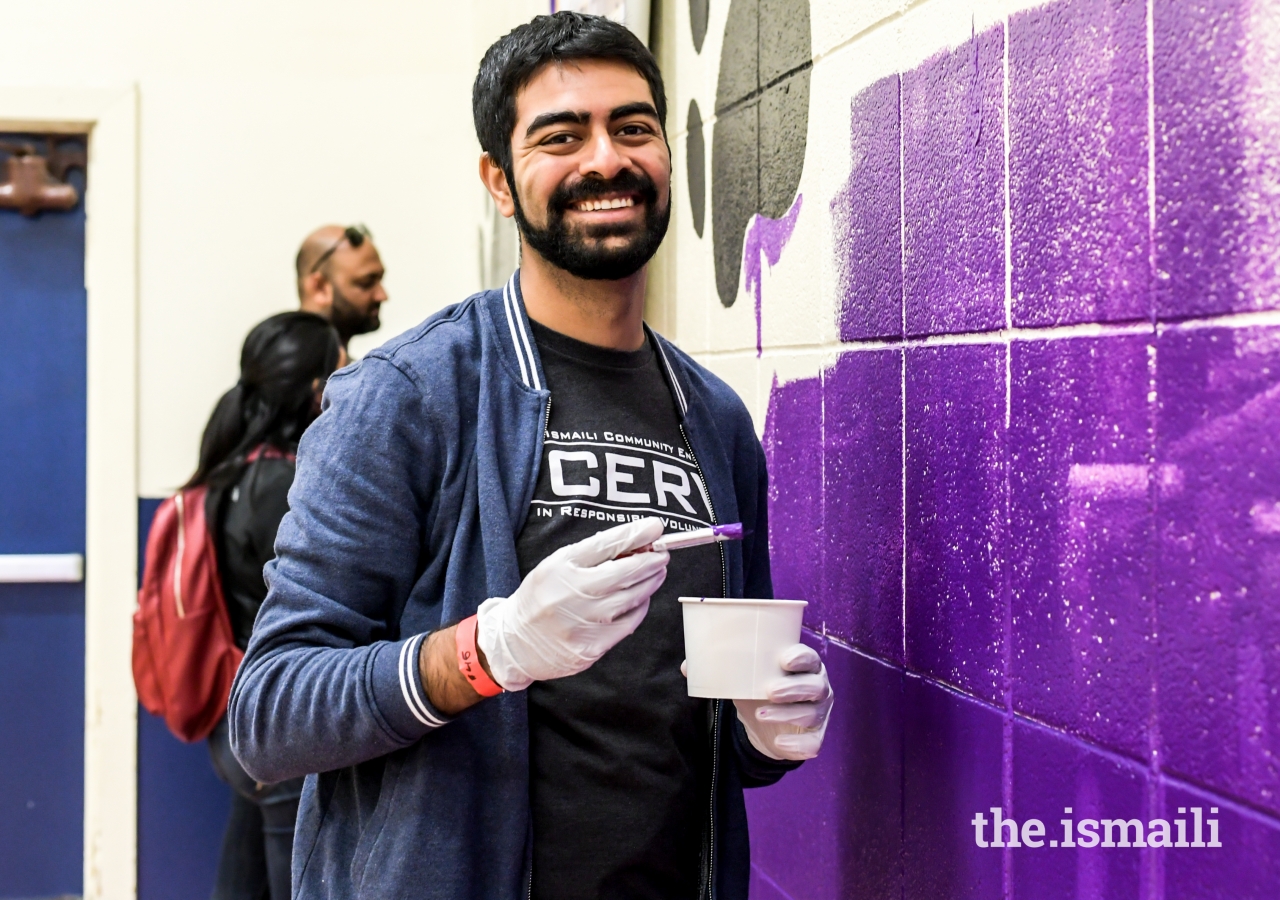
[229,13,831,900]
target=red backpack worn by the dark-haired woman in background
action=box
[133,486,244,743]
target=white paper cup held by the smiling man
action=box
[680,597,809,700]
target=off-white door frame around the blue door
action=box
[0,84,138,900]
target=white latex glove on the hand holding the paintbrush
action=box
[476,518,669,690]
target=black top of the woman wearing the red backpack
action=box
[205,456,296,650]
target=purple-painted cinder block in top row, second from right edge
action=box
[1009,0,1151,325]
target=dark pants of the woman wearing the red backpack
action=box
[209,718,302,900]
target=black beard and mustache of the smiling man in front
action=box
[508,169,671,282]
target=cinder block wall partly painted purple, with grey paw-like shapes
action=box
[650,0,1280,900]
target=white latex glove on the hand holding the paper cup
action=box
[733,644,835,759]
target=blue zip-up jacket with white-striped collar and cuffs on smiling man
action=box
[228,273,796,900]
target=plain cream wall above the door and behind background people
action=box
[0,0,547,495]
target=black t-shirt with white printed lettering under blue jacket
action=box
[516,323,722,900]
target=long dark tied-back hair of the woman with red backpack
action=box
[183,312,339,488]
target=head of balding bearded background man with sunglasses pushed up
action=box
[294,225,387,365]
